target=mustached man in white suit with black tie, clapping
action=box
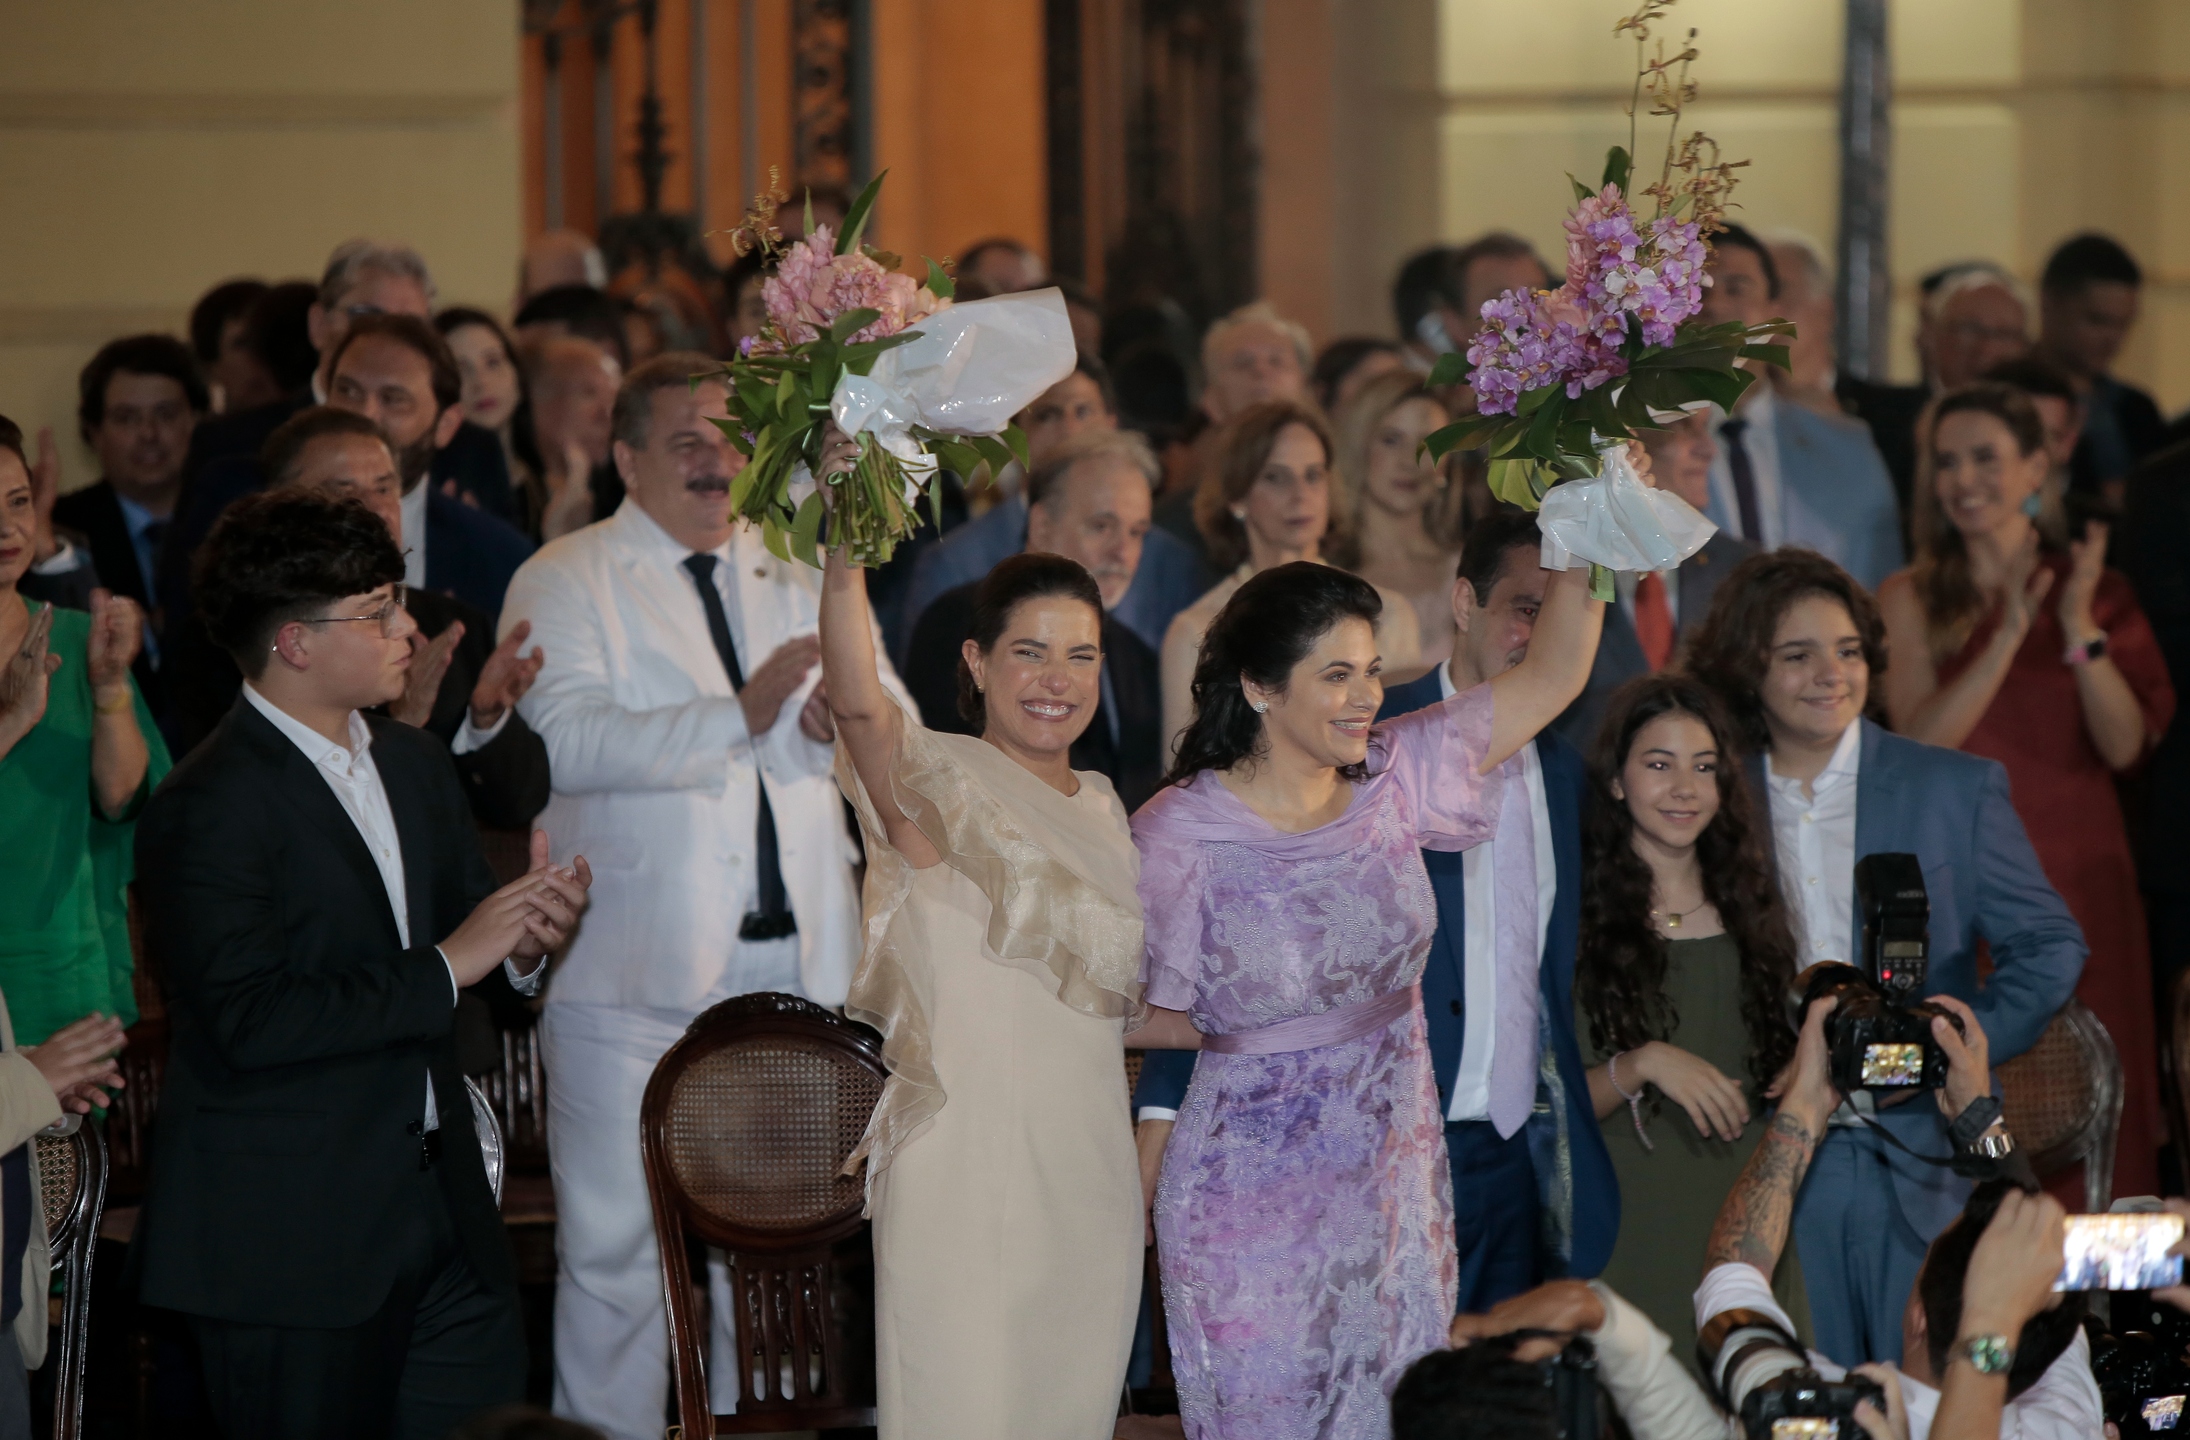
[502,355,911,1440]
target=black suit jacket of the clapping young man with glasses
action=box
[131,700,517,1328]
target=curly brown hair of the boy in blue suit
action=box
[1682,547,1886,751]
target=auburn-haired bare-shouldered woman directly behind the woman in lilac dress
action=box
[1161,391,1424,755]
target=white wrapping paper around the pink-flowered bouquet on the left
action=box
[830,289,1077,479]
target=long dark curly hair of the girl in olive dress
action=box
[1575,674,1796,1090]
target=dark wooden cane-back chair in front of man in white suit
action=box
[639,994,885,1440]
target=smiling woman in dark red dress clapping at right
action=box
[1879,383,2175,1208]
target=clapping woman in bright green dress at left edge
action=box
[0,416,169,1046]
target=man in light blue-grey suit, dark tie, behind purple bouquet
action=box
[1704,225,1903,589]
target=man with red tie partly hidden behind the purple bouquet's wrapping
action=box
[1551,411,1756,755]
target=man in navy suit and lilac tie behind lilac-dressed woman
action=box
[1137,510,1621,1313]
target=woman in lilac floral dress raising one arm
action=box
[1132,562,1603,1440]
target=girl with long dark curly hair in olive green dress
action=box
[1575,674,1807,1355]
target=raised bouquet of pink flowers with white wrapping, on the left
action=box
[718,175,1073,567]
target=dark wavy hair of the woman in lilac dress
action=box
[1163,560,1384,786]
